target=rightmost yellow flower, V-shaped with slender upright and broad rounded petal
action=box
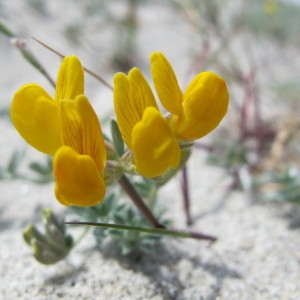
[150,52,229,141]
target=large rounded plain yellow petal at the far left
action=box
[10,84,61,155]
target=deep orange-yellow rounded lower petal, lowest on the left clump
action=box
[53,146,106,206]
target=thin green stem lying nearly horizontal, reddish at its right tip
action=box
[65,222,217,243]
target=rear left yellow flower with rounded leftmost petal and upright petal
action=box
[10,56,84,155]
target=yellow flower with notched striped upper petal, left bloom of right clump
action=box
[114,68,180,178]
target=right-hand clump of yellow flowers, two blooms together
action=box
[114,52,229,178]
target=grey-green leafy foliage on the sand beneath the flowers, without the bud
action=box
[72,181,169,255]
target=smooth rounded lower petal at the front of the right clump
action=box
[132,107,180,178]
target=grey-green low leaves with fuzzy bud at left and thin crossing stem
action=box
[23,175,215,265]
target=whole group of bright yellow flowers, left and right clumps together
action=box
[11,52,229,206]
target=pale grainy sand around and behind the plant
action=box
[0,1,300,300]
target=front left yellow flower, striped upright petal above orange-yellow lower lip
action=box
[53,95,106,206]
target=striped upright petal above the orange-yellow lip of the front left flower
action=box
[60,95,106,172]
